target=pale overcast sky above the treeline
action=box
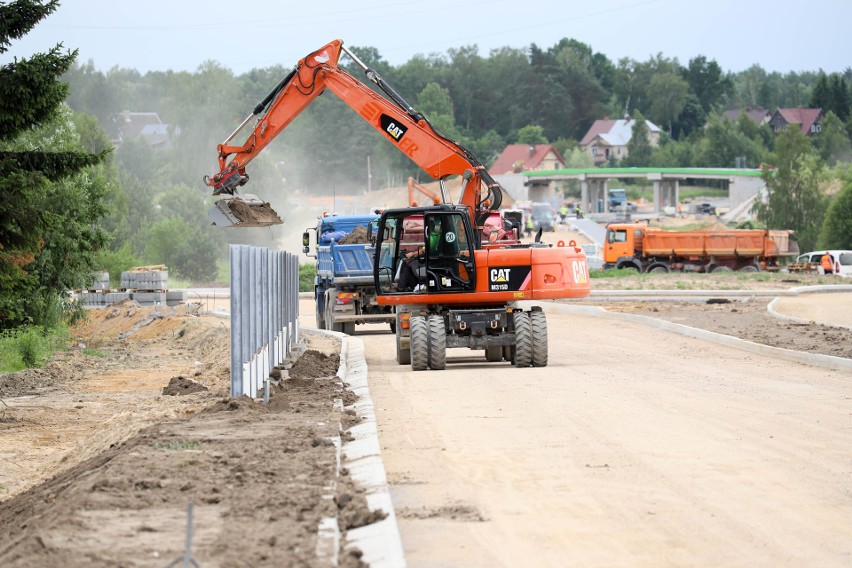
[0,0,852,74]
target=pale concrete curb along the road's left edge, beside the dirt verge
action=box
[312,328,405,568]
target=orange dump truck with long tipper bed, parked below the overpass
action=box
[604,223,799,272]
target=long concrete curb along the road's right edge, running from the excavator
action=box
[523,302,852,372]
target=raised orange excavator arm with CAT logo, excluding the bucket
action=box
[204,39,502,226]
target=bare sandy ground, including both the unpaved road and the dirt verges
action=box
[0,229,852,567]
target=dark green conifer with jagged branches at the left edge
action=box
[0,0,104,329]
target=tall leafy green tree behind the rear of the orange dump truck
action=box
[755,128,826,250]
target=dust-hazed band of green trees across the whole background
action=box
[0,0,852,329]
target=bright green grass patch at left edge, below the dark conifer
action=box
[0,326,69,373]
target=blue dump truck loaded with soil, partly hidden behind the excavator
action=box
[302,215,395,334]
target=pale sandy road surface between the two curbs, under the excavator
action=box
[342,314,852,568]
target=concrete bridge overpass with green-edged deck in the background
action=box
[522,168,765,213]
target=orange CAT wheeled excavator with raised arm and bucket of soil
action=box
[204,40,589,370]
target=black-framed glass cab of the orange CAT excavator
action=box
[374,205,476,295]
